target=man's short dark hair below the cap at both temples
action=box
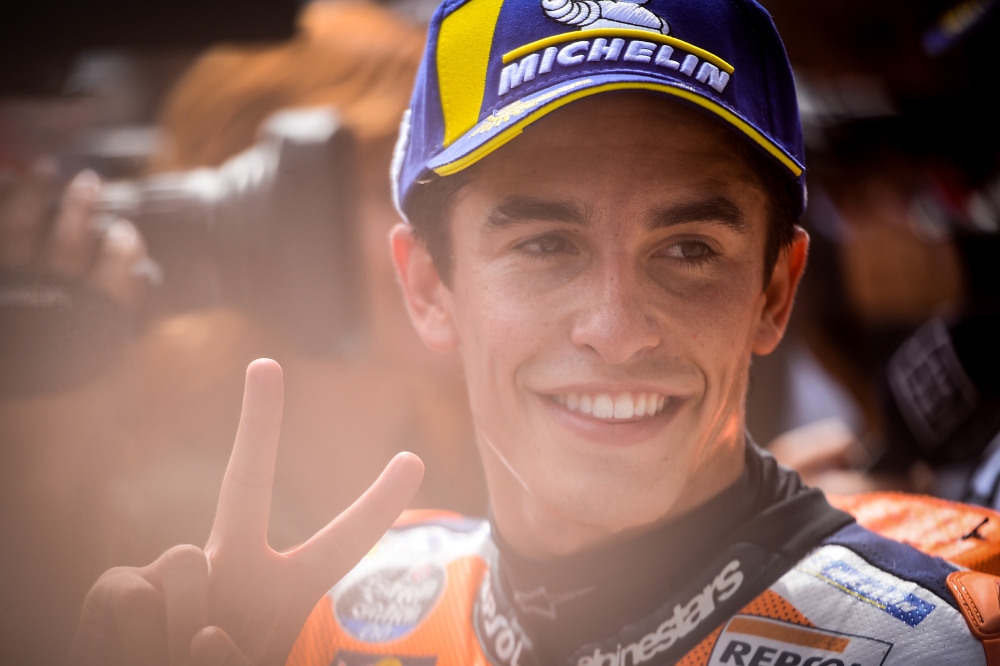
[403,137,798,289]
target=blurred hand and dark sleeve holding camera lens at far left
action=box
[0,158,154,396]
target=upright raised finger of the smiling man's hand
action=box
[209,358,284,544]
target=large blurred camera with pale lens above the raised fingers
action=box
[99,108,363,355]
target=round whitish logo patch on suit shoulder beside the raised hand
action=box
[335,563,445,643]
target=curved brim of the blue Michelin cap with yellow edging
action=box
[427,73,803,178]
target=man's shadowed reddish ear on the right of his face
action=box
[753,226,809,356]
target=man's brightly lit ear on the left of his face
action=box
[389,224,458,352]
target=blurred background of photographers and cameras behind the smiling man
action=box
[0,0,1000,664]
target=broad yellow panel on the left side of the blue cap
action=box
[437,0,503,146]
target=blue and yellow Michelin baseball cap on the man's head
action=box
[392,0,805,215]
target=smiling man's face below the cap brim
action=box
[392,94,804,548]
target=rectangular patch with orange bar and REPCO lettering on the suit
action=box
[708,615,892,666]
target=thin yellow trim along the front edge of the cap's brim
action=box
[434,81,802,178]
